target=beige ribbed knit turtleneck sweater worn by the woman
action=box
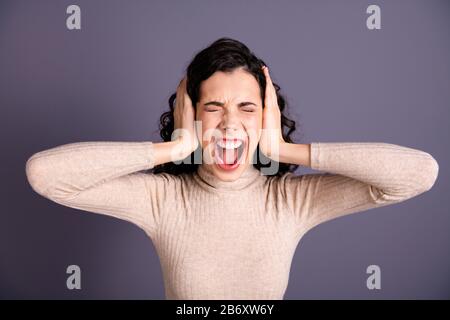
[26,141,439,299]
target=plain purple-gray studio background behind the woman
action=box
[0,0,450,299]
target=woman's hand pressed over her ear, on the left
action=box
[172,76,199,158]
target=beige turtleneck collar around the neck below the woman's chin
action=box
[195,164,263,190]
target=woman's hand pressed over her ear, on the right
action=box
[259,66,285,161]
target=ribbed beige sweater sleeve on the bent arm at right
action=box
[281,142,439,231]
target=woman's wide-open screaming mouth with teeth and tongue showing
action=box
[214,138,247,171]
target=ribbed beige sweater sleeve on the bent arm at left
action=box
[26,141,171,232]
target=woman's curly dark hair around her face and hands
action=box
[152,37,298,175]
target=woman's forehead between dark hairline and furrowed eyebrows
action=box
[200,68,260,99]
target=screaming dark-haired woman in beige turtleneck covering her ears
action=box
[26,38,438,299]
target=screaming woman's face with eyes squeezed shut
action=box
[196,68,262,181]
